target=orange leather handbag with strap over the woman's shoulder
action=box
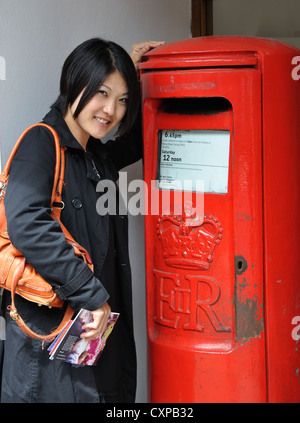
[0,123,93,342]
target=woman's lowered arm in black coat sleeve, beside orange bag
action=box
[5,127,109,310]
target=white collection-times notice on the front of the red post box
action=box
[159,130,230,194]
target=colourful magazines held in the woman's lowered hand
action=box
[48,309,119,366]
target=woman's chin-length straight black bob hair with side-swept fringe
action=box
[52,38,139,135]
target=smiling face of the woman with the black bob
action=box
[65,71,128,148]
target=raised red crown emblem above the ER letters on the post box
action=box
[157,204,223,270]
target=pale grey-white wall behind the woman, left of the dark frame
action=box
[0,0,191,402]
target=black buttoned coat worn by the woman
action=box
[1,109,142,402]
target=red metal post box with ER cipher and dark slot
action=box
[141,37,300,402]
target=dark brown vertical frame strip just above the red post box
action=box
[192,0,213,37]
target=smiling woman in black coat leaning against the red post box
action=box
[1,38,161,403]
